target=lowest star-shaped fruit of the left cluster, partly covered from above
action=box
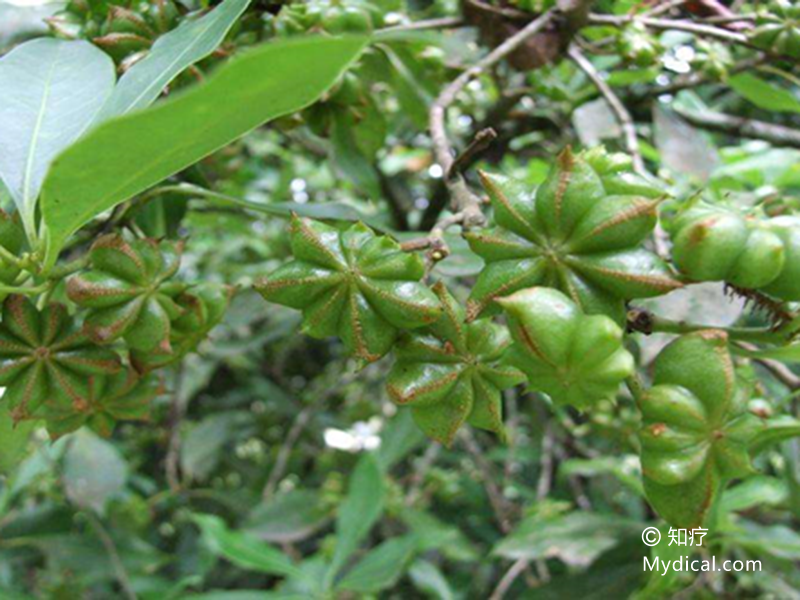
[45,369,163,439]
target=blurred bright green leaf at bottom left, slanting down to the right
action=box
[193,514,300,576]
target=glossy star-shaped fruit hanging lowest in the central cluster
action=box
[386,283,525,445]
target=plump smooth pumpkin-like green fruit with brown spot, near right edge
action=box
[672,203,786,288]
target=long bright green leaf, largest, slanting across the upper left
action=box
[42,37,366,266]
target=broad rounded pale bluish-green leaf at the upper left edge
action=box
[0,38,115,234]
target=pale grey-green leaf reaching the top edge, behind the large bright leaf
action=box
[96,0,250,123]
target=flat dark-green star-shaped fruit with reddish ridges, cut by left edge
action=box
[0,295,120,420]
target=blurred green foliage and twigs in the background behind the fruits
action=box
[0,0,800,600]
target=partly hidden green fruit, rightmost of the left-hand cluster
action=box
[131,283,235,373]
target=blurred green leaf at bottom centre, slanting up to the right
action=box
[336,536,415,594]
